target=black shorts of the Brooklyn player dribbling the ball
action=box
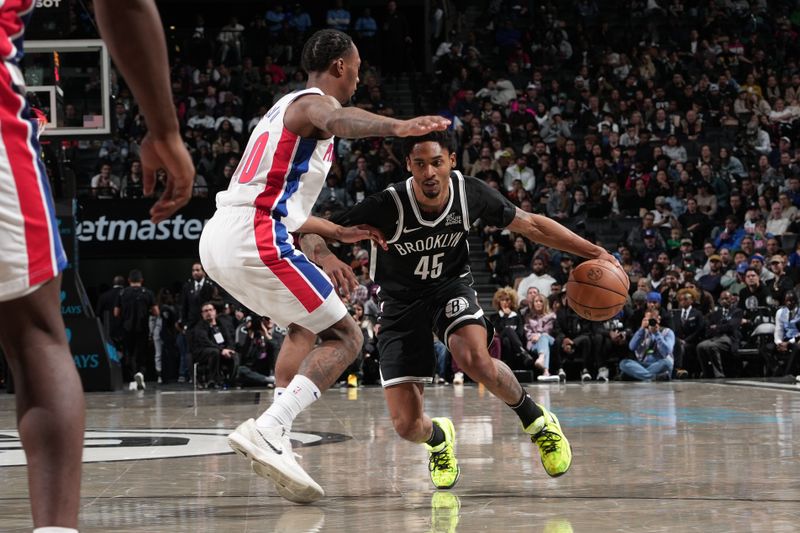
[378,280,486,387]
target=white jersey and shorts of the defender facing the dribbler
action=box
[200,88,347,333]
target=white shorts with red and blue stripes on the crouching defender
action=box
[200,207,347,333]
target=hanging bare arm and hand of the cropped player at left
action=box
[94,0,194,222]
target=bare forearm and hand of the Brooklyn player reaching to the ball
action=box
[507,208,622,268]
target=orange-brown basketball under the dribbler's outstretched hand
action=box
[567,259,630,322]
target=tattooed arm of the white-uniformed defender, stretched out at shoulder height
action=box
[301,96,450,139]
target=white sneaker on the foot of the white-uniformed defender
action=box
[228,418,325,503]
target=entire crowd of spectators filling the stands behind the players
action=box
[42,0,800,379]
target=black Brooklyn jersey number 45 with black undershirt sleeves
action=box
[333,171,516,300]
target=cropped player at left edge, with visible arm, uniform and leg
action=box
[0,0,194,533]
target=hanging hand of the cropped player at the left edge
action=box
[141,131,195,223]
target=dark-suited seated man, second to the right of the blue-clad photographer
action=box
[697,290,753,378]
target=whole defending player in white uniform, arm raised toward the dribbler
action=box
[200,30,450,502]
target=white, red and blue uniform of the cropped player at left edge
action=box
[0,0,67,301]
